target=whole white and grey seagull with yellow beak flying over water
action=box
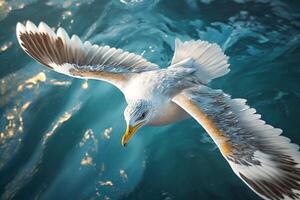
[16,21,300,200]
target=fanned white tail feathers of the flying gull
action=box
[171,39,230,83]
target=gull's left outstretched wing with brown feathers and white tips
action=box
[16,21,158,88]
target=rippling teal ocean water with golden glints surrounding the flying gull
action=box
[0,0,300,200]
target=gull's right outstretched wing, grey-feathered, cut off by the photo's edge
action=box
[173,86,300,200]
